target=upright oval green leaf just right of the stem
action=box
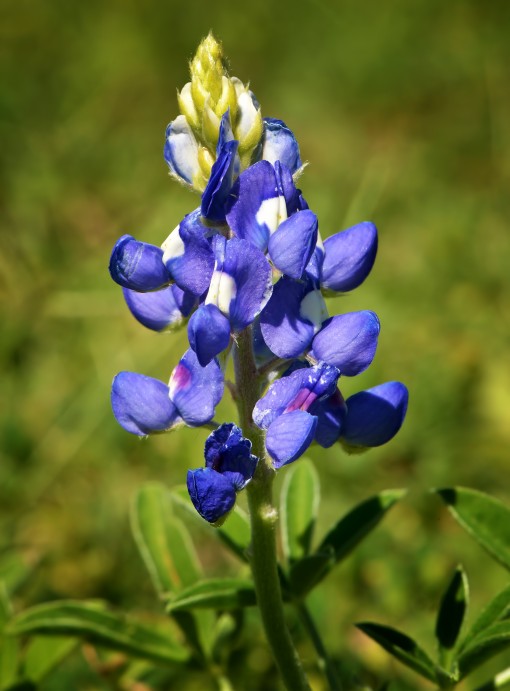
[281,458,320,564]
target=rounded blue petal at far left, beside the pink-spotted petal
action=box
[111,372,182,437]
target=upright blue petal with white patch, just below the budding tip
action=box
[226,161,281,252]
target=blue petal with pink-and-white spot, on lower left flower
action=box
[169,349,223,427]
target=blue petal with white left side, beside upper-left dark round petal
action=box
[163,209,214,296]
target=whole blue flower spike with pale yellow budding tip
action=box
[110,35,408,523]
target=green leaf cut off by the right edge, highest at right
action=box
[436,487,510,569]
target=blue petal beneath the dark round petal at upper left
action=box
[123,286,182,331]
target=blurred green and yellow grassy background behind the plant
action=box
[0,0,510,689]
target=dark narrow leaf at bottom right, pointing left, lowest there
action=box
[356,622,438,683]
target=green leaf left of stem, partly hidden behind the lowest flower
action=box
[171,486,251,562]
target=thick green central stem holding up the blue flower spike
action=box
[233,328,310,691]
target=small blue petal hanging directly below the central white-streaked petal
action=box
[188,305,230,367]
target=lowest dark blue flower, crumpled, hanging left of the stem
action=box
[187,423,258,524]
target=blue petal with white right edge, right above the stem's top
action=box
[260,276,327,359]
